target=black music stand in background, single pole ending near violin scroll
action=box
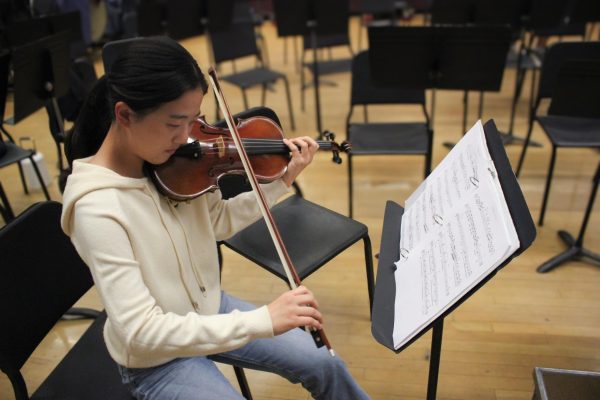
[273,0,349,139]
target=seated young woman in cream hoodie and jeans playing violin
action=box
[62,38,368,400]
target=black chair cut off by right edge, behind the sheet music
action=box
[516,42,600,226]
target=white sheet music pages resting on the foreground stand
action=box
[393,121,519,349]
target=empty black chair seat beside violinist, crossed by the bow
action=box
[224,196,368,281]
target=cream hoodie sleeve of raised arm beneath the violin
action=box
[206,179,290,240]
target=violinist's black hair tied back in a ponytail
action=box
[65,37,208,165]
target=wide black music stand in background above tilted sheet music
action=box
[369,25,512,141]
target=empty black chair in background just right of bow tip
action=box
[209,22,296,130]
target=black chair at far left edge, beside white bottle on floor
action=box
[0,48,50,222]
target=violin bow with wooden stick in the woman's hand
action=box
[208,67,335,356]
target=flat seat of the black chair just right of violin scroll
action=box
[348,123,429,155]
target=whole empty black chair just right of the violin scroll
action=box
[346,51,433,218]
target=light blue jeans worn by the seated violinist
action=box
[119,292,369,400]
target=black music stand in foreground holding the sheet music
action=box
[371,120,536,400]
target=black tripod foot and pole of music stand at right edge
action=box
[537,164,600,272]
